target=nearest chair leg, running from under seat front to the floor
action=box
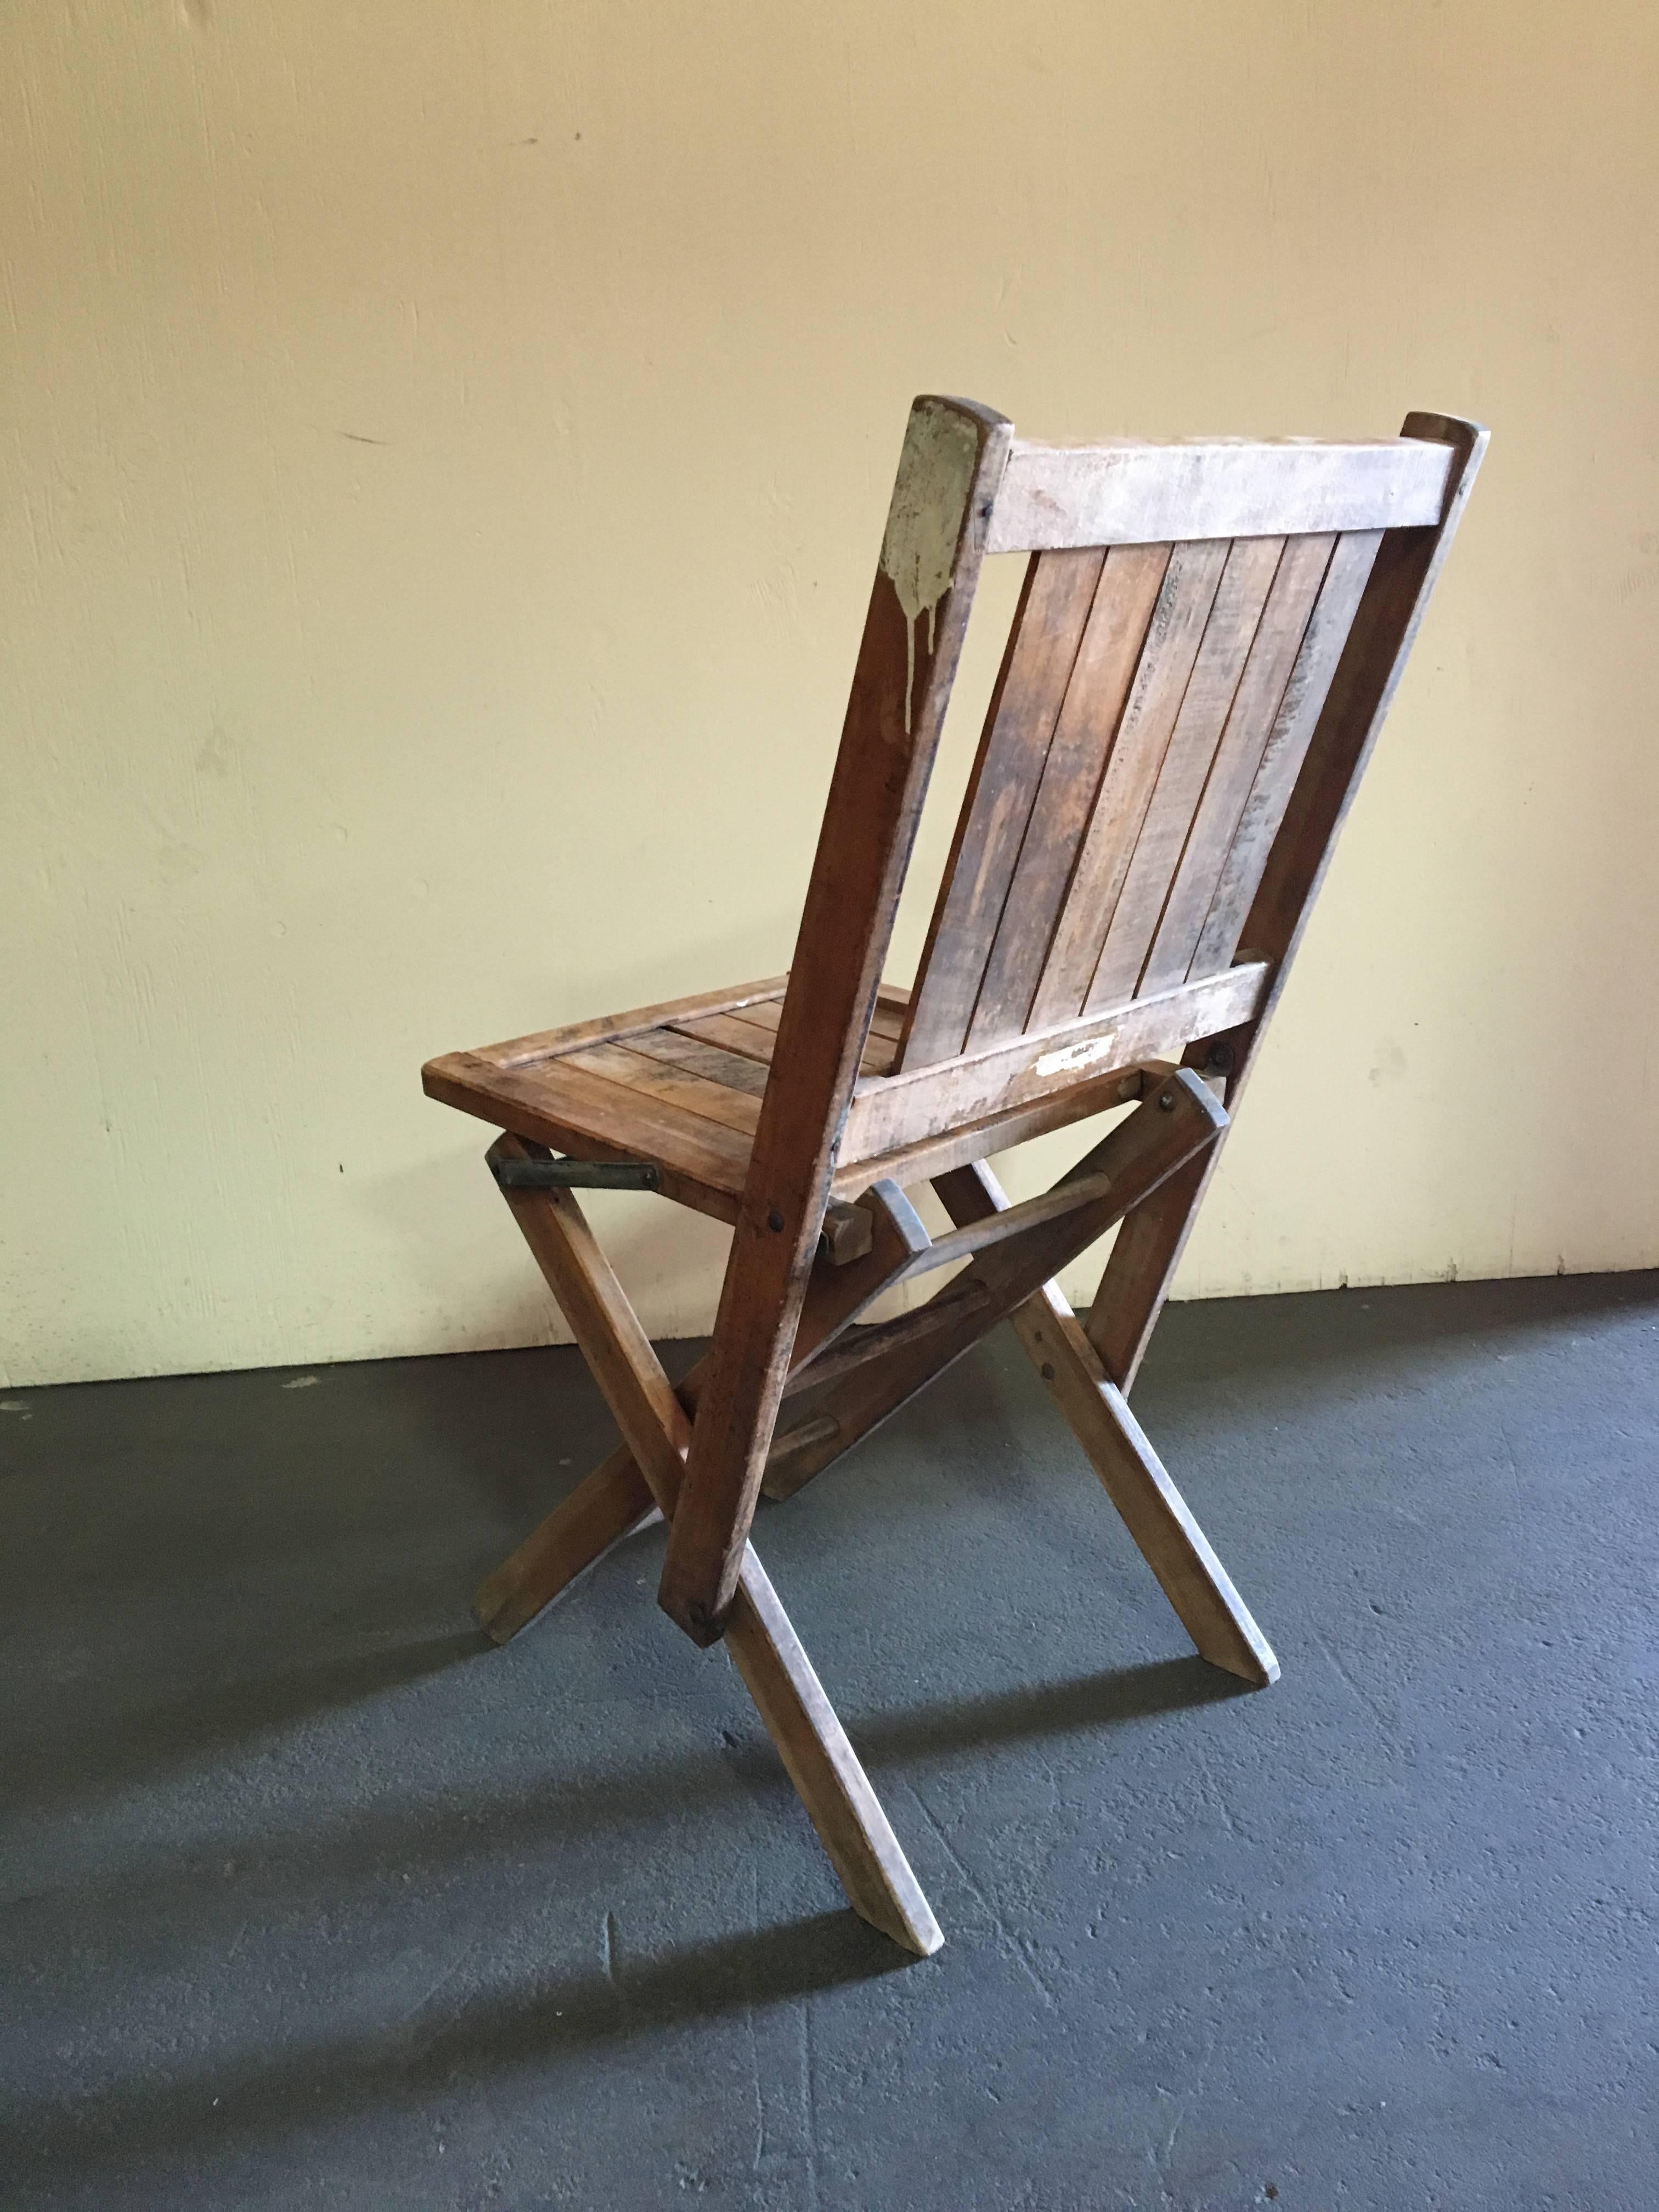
[495,1137,945,1957]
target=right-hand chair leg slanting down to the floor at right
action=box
[934,1159,1278,1688]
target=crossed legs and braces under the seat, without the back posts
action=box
[476,1073,1278,1957]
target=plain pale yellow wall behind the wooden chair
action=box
[0,0,1659,1383]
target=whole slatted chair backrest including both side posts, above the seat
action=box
[750,396,1487,1217]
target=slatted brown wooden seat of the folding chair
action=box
[420,975,907,1221]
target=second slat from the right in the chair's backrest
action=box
[1137,533,1336,991]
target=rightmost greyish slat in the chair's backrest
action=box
[1188,531,1383,975]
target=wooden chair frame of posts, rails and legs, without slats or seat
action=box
[427,396,1487,1955]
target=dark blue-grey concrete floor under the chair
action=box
[0,1274,1659,2212]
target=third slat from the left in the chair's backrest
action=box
[1031,542,1228,1029]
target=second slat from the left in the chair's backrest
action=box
[967,546,1170,1051]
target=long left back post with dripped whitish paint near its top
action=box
[659,396,1013,1644]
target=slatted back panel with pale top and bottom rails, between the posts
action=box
[840,403,1484,1161]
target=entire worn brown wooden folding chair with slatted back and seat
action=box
[425,398,1487,1953]
